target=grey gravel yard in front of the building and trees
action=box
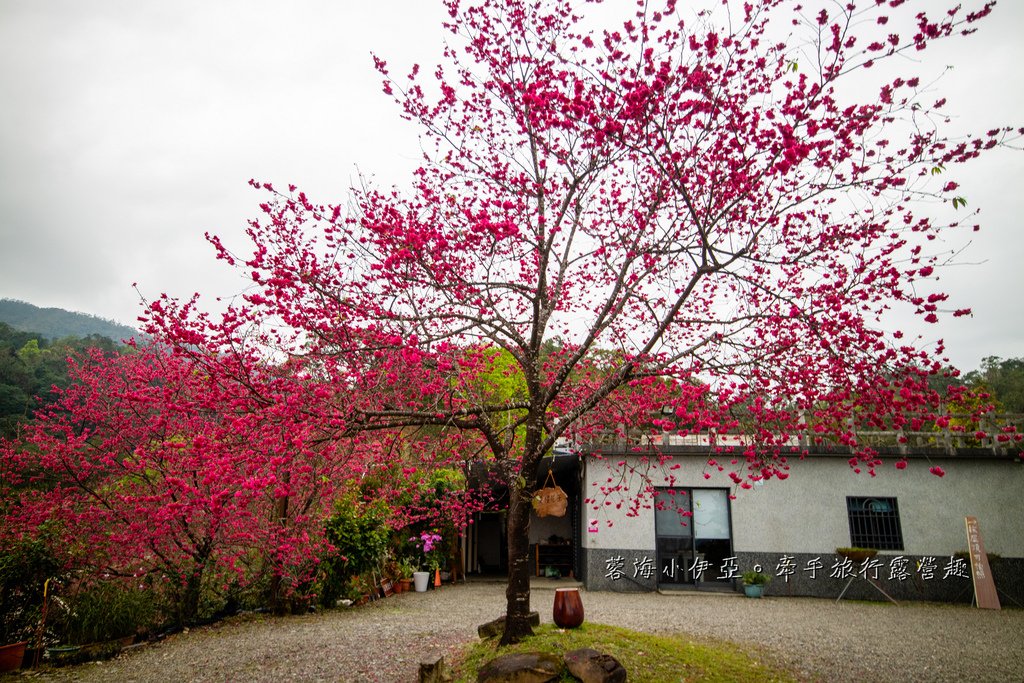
[24,580,1024,683]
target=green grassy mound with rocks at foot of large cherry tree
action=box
[454,624,796,683]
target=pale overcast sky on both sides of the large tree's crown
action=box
[0,0,1024,370]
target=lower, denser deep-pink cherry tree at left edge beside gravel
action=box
[0,346,361,624]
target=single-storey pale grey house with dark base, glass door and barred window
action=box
[573,444,1024,605]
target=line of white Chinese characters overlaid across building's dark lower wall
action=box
[604,555,971,583]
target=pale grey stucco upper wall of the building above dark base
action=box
[581,457,1024,557]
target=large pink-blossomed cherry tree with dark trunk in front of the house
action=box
[138,0,1020,643]
